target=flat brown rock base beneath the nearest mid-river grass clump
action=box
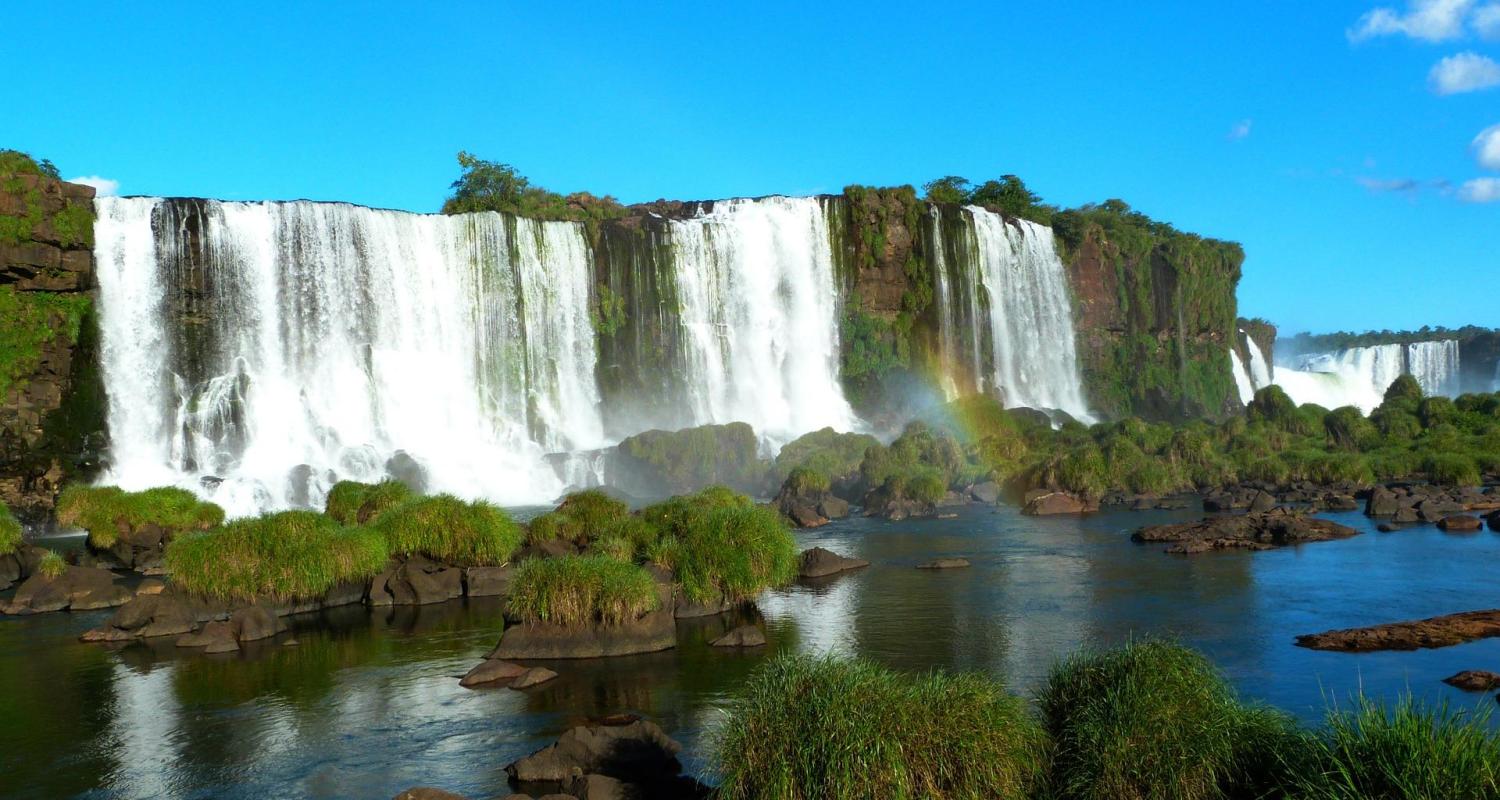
[488,609,677,660]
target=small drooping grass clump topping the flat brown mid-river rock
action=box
[507,555,662,626]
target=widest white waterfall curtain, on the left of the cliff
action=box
[95,198,603,515]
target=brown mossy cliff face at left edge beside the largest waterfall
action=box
[0,165,105,513]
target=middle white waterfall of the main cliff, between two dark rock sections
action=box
[671,197,857,447]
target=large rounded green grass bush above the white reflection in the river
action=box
[653,506,798,603]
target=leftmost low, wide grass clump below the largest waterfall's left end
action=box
[57,485,224,548]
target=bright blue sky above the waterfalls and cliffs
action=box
[0,0,1500,333]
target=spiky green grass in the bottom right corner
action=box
[1296,696,1500,800]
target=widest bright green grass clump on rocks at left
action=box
[165,510,390,600]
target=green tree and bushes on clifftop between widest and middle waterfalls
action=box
[443,152,629,224]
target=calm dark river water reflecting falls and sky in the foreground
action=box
[0,507,1500,798]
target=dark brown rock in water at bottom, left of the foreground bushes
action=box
[506,720,683,783]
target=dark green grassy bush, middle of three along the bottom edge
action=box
[1038,641,1275,800]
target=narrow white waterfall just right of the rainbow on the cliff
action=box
[932,206,1092,420]
